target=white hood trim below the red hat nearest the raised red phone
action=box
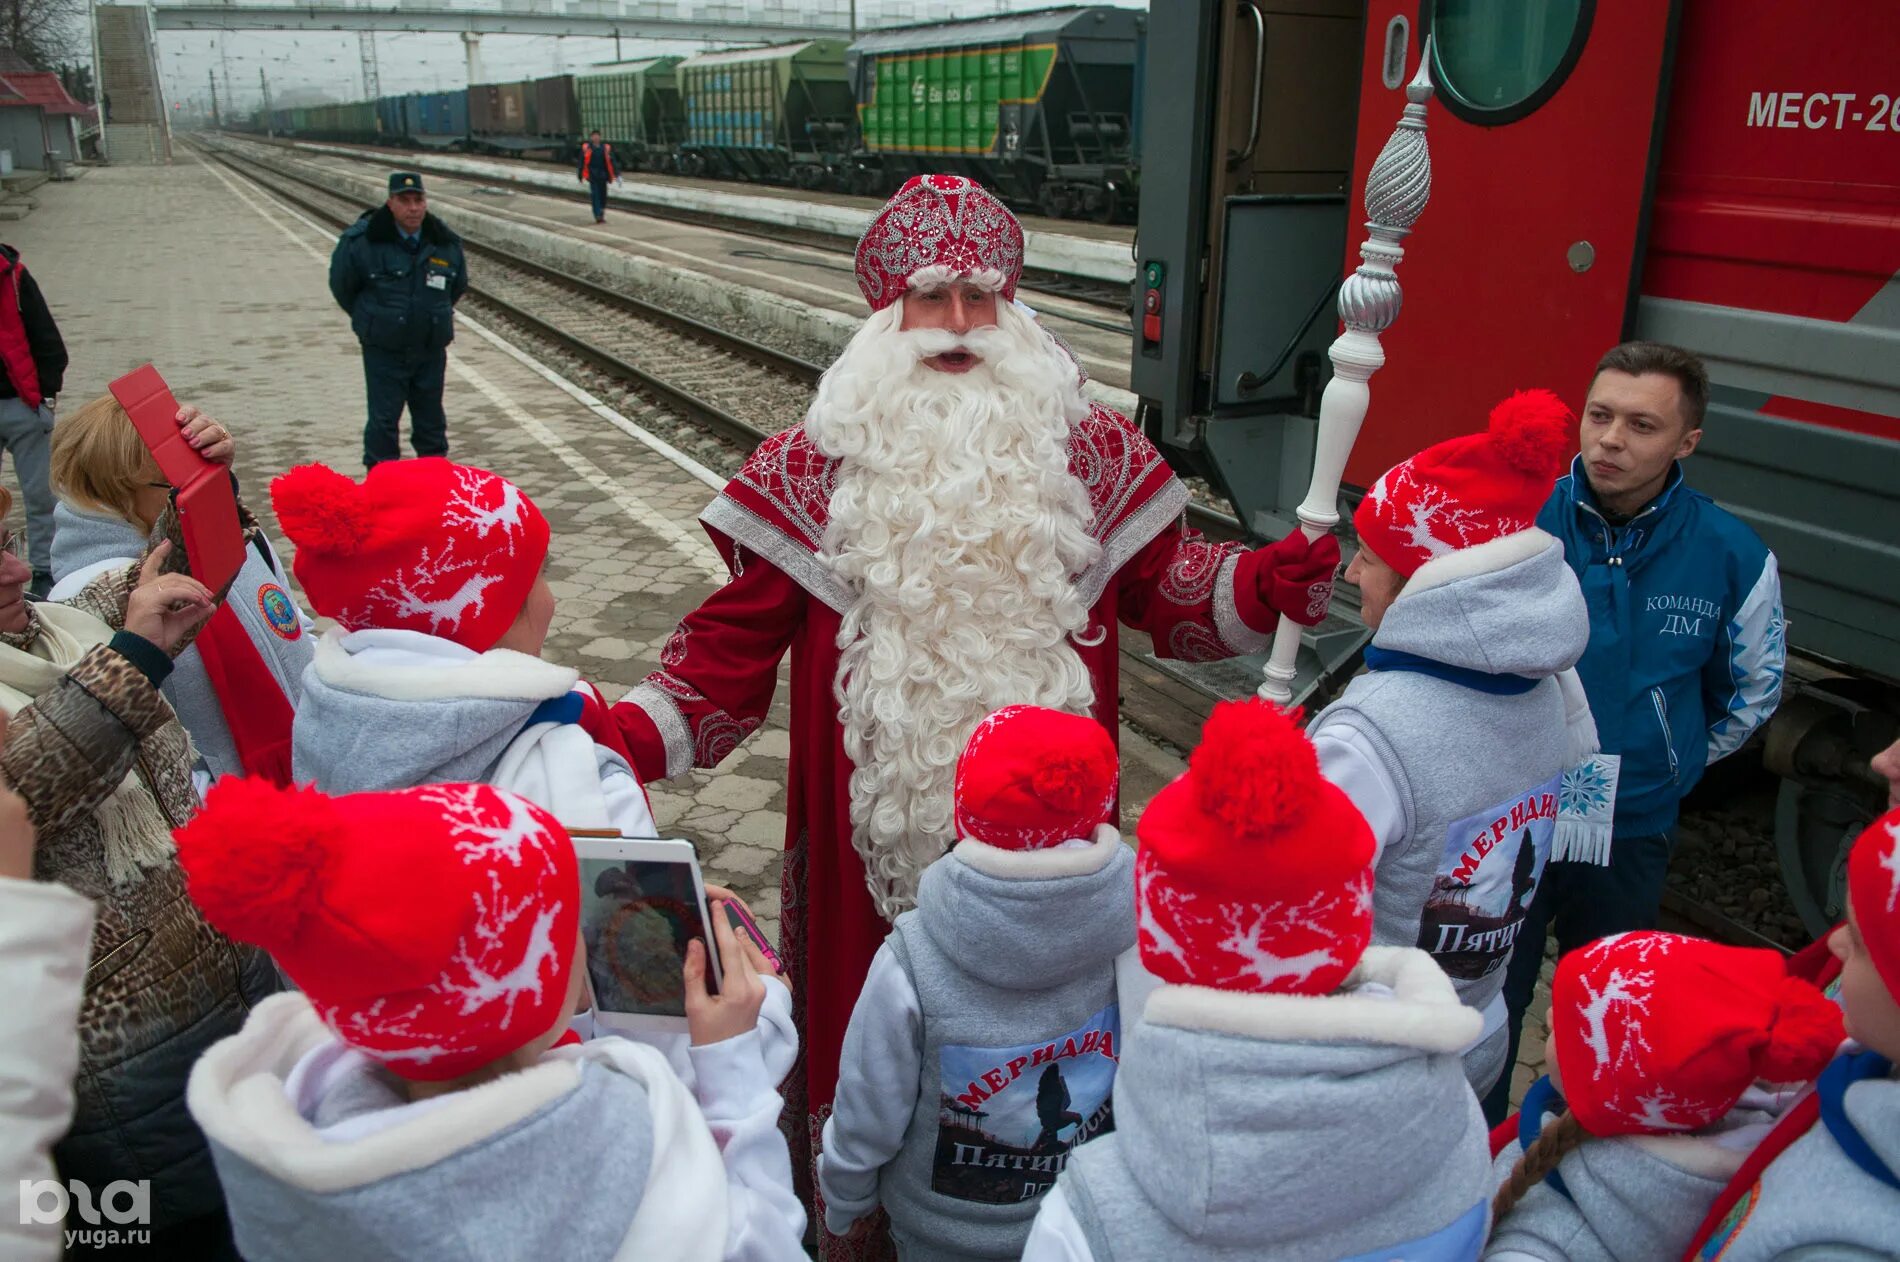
[312,627,580,701]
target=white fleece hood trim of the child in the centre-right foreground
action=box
[1144,947,1484,1053]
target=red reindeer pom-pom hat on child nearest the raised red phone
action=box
[270,456,549,652]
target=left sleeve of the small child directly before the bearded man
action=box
[819,943,923,1235]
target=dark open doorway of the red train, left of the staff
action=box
[1131,0,1364,532]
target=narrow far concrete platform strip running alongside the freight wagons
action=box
[260,141,1134,285]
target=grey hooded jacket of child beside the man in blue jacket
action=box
[1311,530,1590,1093]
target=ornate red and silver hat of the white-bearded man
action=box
[857,175,1022,312]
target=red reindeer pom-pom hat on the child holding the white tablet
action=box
[173,777,581,1081]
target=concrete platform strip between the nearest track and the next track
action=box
[211,137,1136,404]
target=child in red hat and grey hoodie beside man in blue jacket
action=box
[1311,390,1596,1095]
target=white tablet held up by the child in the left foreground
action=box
[574,836,720,1034]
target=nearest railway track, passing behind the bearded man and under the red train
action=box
[201,148,1782,950]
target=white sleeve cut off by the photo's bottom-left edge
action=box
[0,876,93,1262]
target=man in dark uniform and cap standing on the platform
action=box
[331,171,469,468]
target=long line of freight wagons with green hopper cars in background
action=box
[253,6,1148,220]
